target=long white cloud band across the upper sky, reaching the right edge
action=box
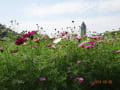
[24,0,120,17]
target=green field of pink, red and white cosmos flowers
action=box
[0,31,120,90]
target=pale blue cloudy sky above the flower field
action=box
[0,0,120,33]
